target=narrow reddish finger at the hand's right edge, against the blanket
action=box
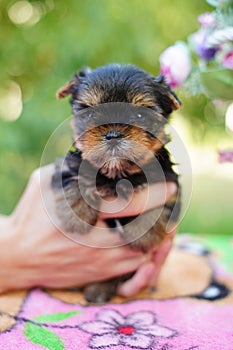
[149,229,176,288]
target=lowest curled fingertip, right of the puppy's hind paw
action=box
[118,262,155,297]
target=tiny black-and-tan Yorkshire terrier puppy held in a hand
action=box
[52,64,180,302]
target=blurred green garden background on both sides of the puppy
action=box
[0,0,233,234]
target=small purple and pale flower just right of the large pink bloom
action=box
[192,30,219,61]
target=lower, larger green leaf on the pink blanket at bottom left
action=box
[24,322,65,350]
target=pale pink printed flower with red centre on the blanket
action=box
[79,310,177,349]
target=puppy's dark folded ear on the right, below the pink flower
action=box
[153,75,181,116]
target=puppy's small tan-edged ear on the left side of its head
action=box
[56,67,91,100]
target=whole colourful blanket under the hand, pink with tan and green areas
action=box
[0,235,233,350]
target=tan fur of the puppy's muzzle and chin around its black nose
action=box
[76,124,163,177]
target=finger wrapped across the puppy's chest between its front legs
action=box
[100,182,177,219]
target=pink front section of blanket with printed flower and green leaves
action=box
[0,289,233,350]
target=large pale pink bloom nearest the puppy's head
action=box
[159,42,191,88]
